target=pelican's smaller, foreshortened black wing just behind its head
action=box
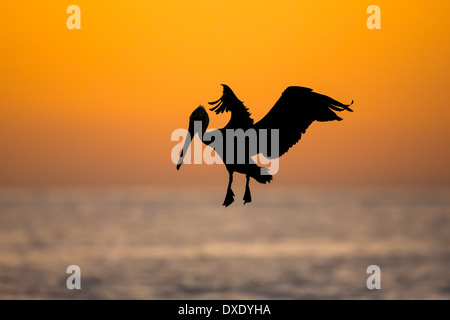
[208,84,253,129]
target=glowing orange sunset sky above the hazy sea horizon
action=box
[0,0,450,187]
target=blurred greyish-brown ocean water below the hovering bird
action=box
[0,186,450,299]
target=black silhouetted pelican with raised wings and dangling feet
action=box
[177,84,353,207]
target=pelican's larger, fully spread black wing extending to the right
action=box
[254,87,353,159]
